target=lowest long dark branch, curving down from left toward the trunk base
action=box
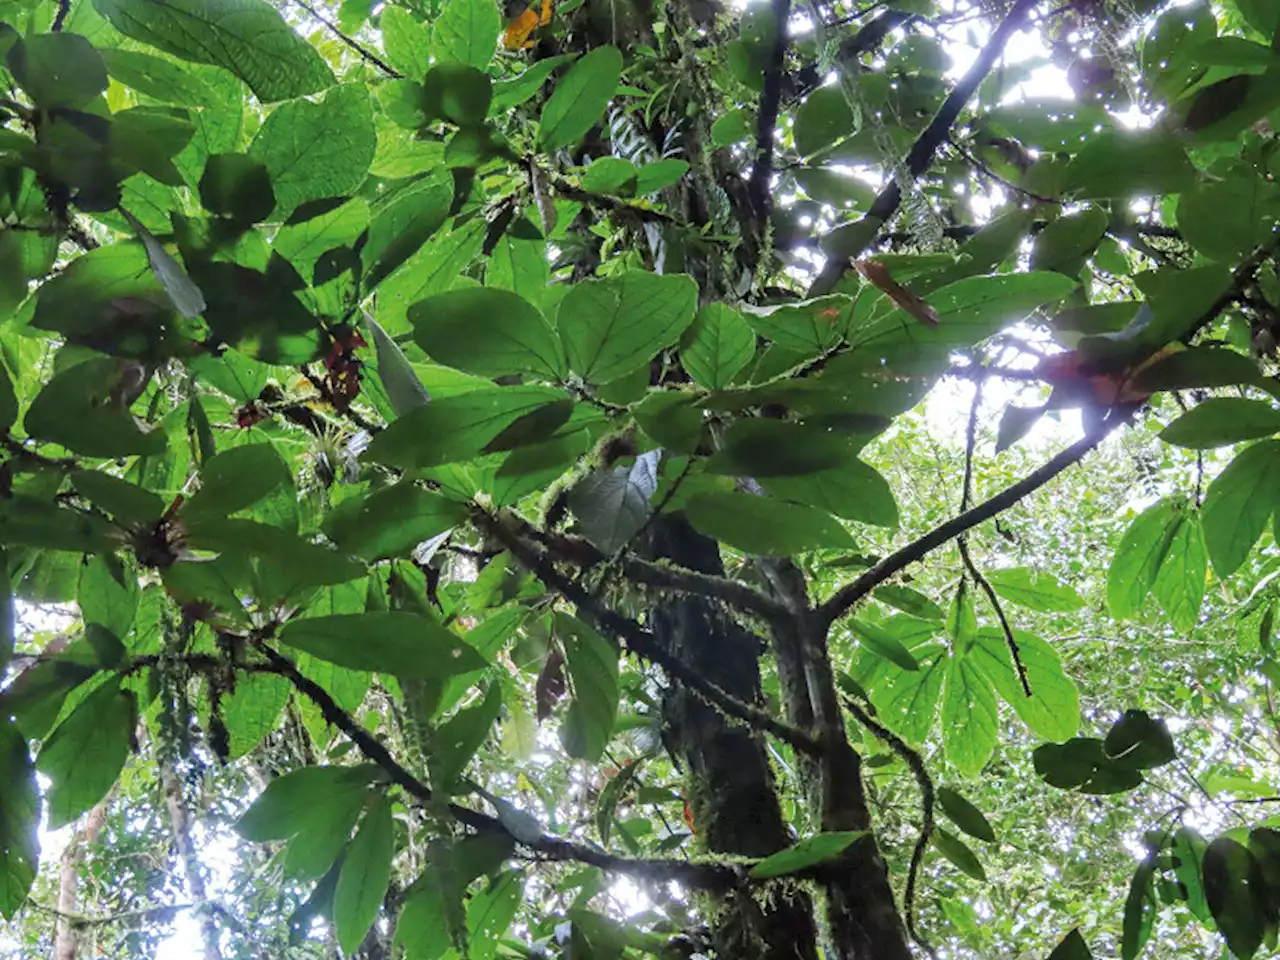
[255,644,741,890]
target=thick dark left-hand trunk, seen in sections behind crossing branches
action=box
[650,516,817,960]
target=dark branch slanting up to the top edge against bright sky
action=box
[809,0,1039,297]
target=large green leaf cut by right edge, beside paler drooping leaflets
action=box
[1201,440,1280,577]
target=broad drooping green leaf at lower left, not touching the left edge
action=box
[36,678,134,829]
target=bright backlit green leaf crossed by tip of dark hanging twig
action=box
[969,627,1080,740]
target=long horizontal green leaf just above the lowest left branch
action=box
[279,611,486,680]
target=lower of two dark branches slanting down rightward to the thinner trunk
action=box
[472,508,823,756]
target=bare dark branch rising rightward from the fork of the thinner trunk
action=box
[817,411,1129,626]
